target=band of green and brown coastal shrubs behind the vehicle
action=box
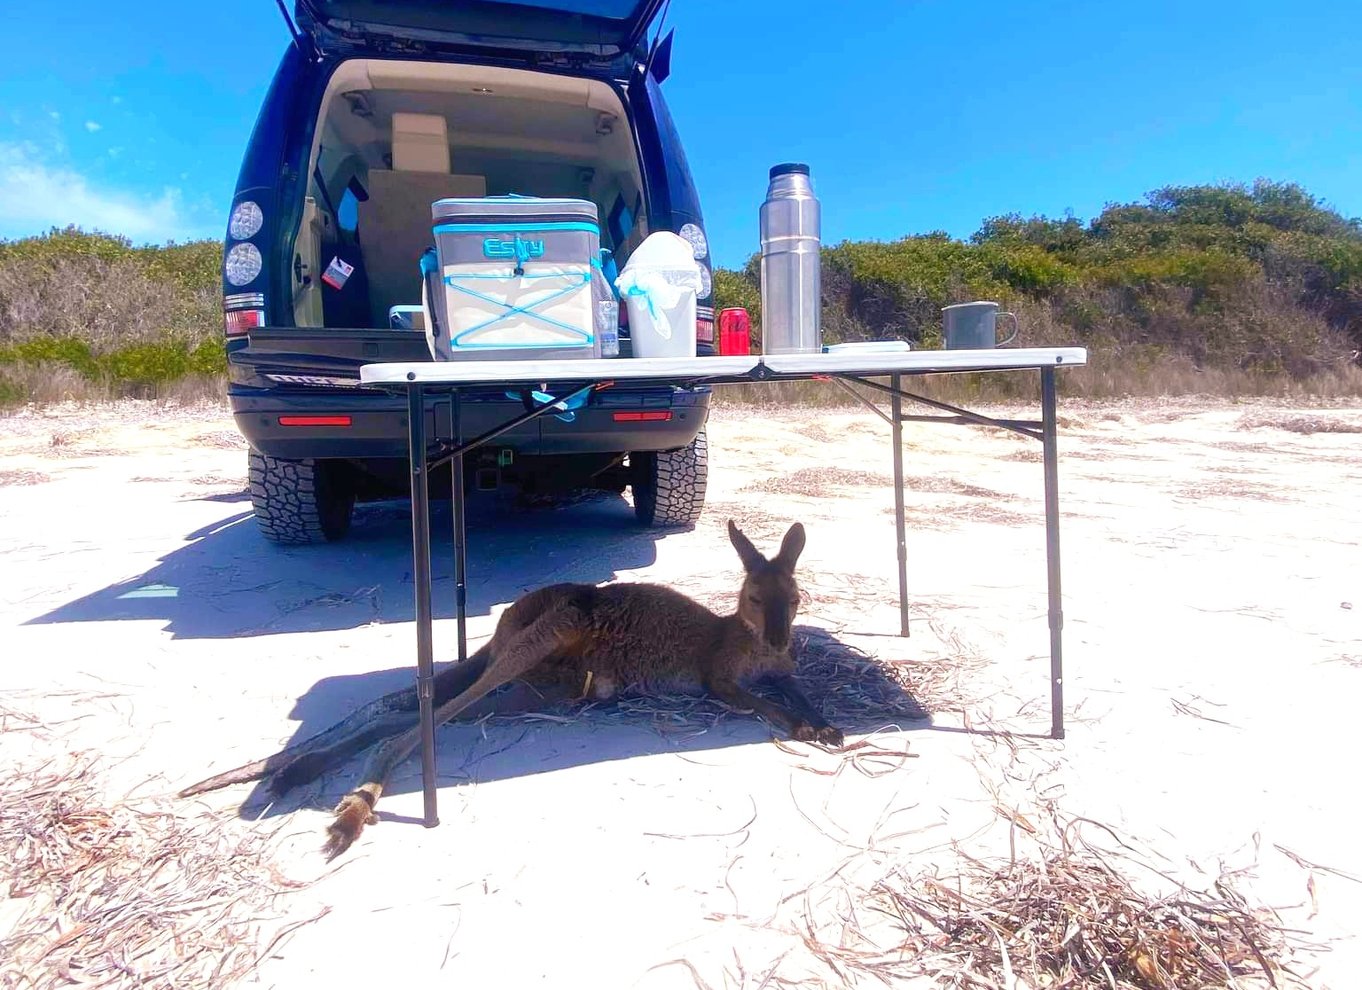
[0,180,1362,404]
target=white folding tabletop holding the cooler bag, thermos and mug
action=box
[360,347,1088,385]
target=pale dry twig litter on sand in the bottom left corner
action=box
[0,712,315,990]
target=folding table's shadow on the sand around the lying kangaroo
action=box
[201,625,933,823]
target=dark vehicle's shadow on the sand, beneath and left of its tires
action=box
[26,494,665,639]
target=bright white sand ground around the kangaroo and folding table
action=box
[0,402,1362,990]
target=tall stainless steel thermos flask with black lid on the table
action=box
[761,162,823,354]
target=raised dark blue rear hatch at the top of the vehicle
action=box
[294,0,663,61]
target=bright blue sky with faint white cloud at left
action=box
[0,0,1362,266]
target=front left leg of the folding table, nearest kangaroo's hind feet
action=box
[407,384,440,828]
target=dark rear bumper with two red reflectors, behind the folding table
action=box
[227,384,710,459]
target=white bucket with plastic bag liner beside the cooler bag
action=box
[614,230,701,358]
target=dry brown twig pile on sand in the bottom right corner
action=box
[872,823,1306,990]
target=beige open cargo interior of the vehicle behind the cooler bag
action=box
[291,59,648,328]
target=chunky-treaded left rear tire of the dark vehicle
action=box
[249,451,354,543]
